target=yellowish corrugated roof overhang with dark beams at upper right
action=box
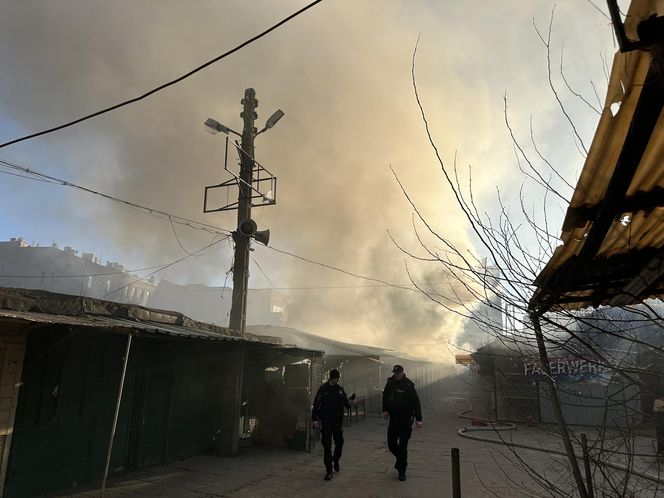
[529,0,664,313]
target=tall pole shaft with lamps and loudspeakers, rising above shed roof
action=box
[229,88,258,334]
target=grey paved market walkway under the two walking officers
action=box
[60,396,664,498]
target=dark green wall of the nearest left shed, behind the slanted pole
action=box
[5,326,234,497]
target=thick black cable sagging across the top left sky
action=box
[0,0,323,149]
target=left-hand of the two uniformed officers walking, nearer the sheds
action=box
[311,368,350,481]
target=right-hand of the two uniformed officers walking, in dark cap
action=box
[383,365,422,481]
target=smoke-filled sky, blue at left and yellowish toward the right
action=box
[0,0,625,359]
